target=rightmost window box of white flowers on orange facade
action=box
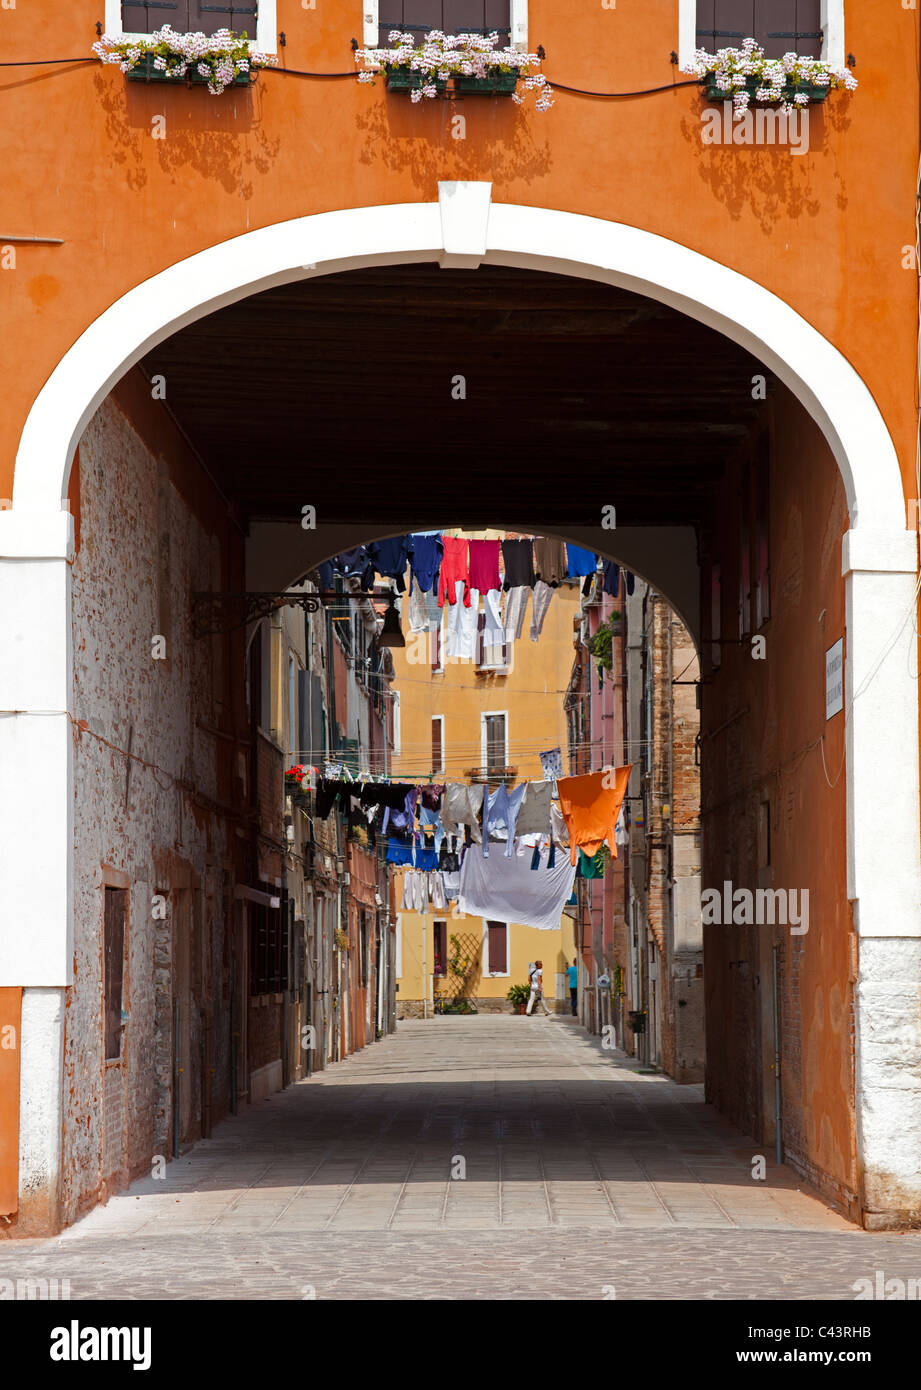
[682,39,857,113]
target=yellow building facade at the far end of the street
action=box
[392,531,579,1017]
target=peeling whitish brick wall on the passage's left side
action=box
[64,398,232,1220]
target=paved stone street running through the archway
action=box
[0,1016,921,1300]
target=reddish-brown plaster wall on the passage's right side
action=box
[702,389,855,1209]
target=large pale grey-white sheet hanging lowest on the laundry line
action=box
[457,849,575,931]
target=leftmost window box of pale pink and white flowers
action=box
[93,24,278,96]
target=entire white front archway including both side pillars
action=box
[0,183,921,1228]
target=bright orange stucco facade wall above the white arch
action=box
[0,0,918,511]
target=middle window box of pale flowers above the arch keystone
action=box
[356,29,553,111]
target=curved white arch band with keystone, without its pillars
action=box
[7,183,906,530]
